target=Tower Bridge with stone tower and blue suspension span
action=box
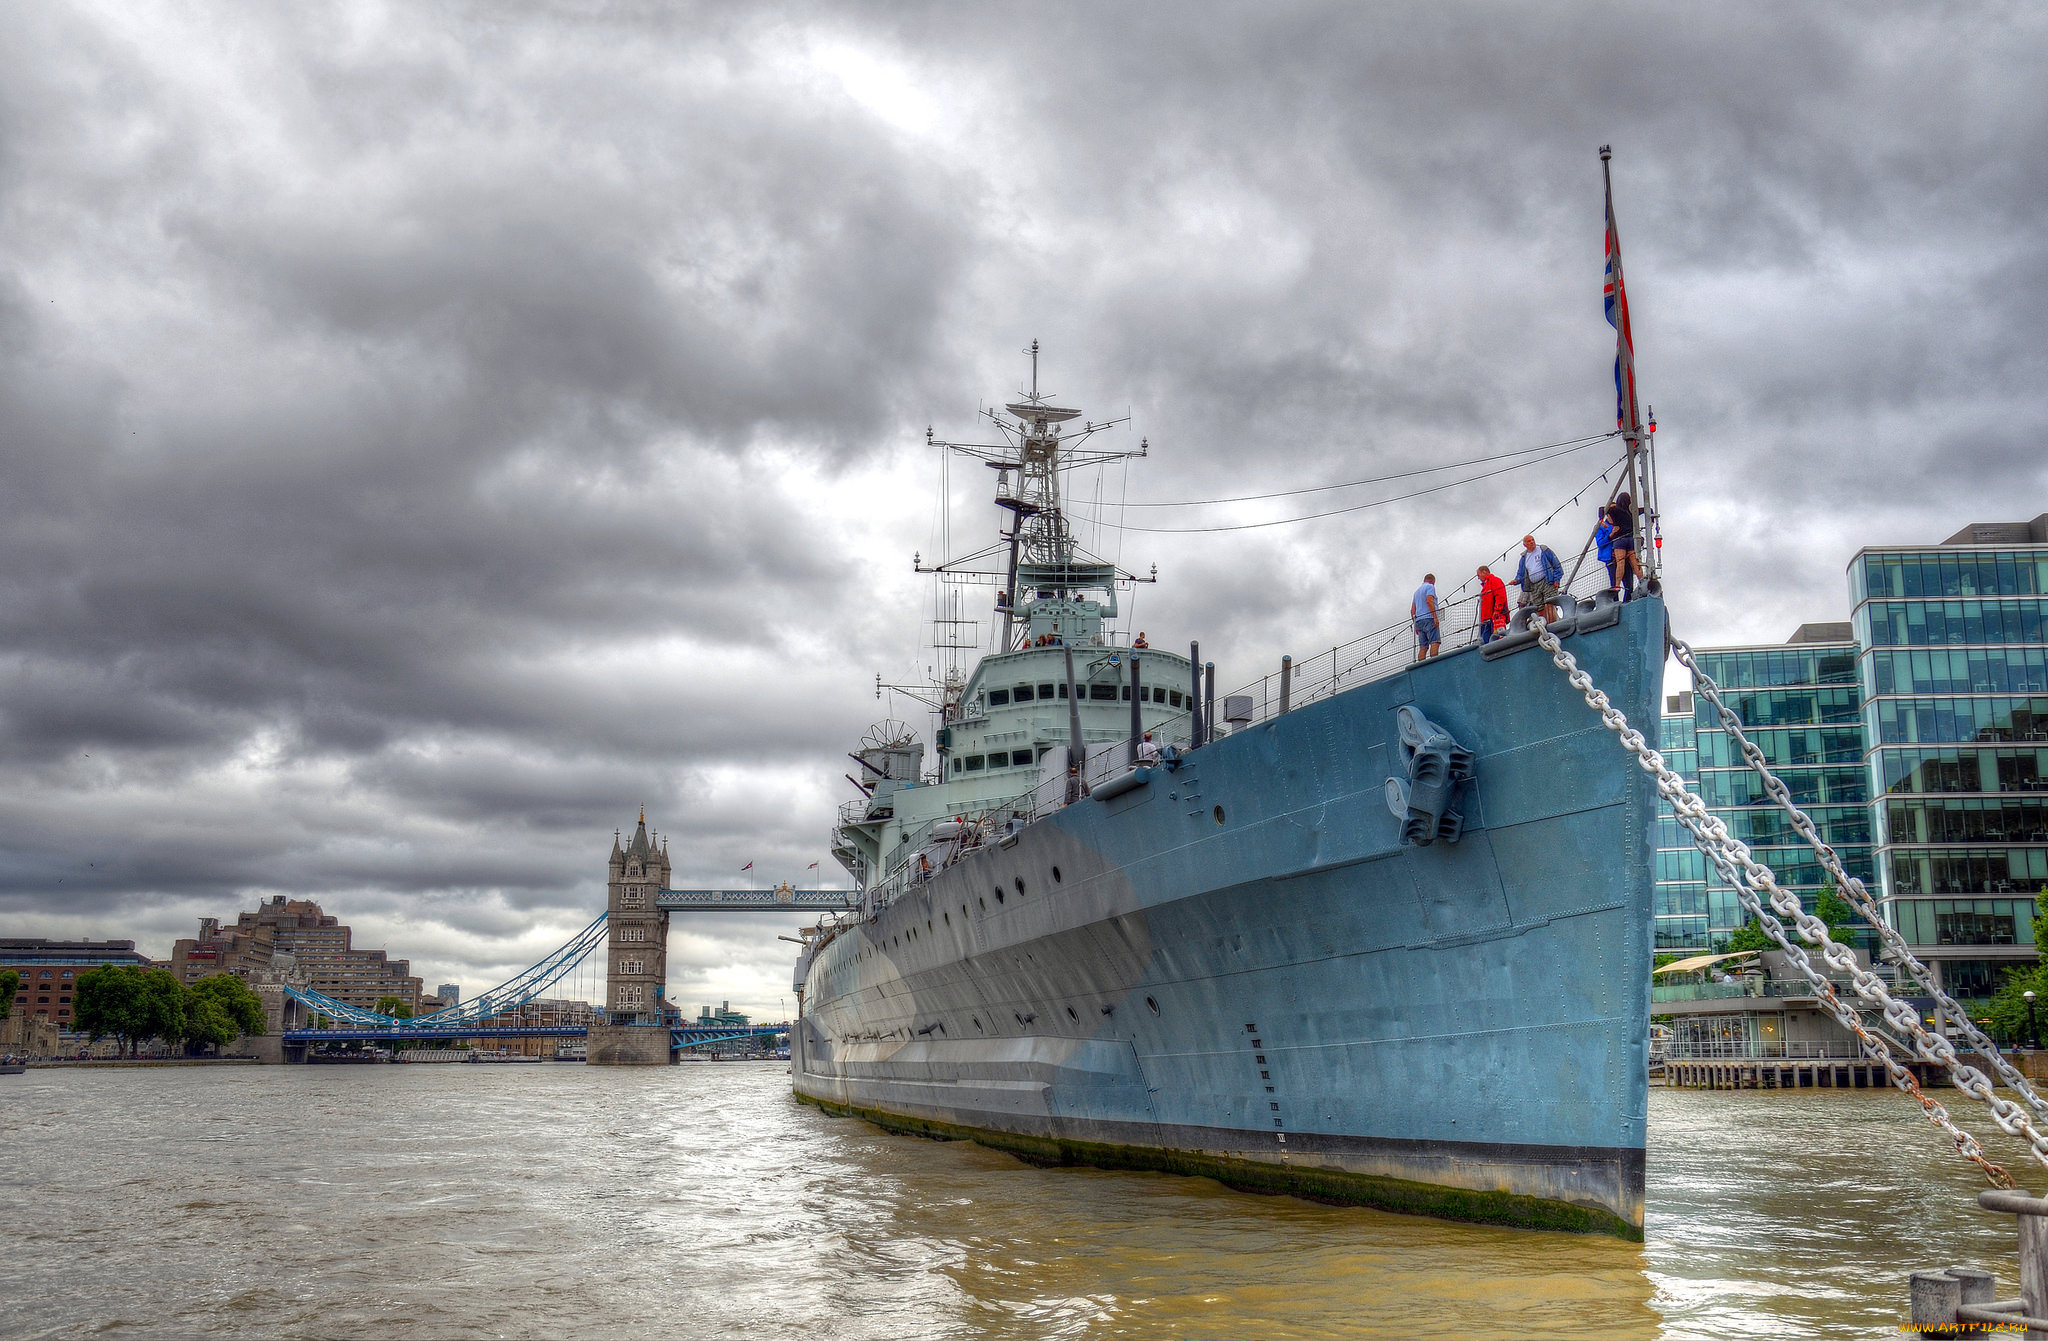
[281,811,860,1065]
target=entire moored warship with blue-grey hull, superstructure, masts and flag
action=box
[791,145,1667,1239]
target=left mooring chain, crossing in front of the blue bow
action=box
[1536,622,2023,1187]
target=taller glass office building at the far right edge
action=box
[1849,516,2048,997]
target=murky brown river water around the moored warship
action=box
[0,1063,2048,1341]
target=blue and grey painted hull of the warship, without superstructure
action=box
[793,600,1665,1239]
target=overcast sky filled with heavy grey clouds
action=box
[0,0,2048,1009]
